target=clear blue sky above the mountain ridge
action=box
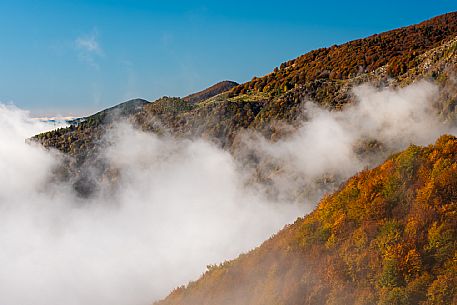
[0,0,457,115]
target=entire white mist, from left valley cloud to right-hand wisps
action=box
[0,82,453,305]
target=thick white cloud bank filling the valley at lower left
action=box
[0,106,300,305]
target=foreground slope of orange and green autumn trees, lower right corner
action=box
[157,136,457,305]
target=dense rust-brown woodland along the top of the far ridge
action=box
[231,13,457,95]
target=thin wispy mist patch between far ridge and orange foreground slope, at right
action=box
[238,81,455,205]
